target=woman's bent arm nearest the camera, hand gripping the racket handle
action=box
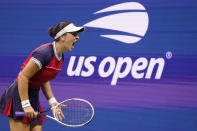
[18,60,39,118]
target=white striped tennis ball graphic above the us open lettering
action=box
[84,2,149,44]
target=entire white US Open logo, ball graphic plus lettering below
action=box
[67,2,166,86]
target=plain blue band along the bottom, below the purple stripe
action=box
[0,109,197,131]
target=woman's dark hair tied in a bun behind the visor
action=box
[48,21,71,41]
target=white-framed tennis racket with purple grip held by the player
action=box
[15,98,94,127]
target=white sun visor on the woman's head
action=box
[54,23,84,39]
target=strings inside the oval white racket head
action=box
[61,101,92,125]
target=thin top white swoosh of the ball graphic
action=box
[94,2,145,14]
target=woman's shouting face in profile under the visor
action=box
[63,32,79,51]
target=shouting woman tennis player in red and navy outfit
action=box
[0,22,84,131]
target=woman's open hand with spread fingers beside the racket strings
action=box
[51,102,66,121]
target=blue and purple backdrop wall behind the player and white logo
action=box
[0,0,197,131]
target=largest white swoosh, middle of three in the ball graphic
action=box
[84,12,148,36]
